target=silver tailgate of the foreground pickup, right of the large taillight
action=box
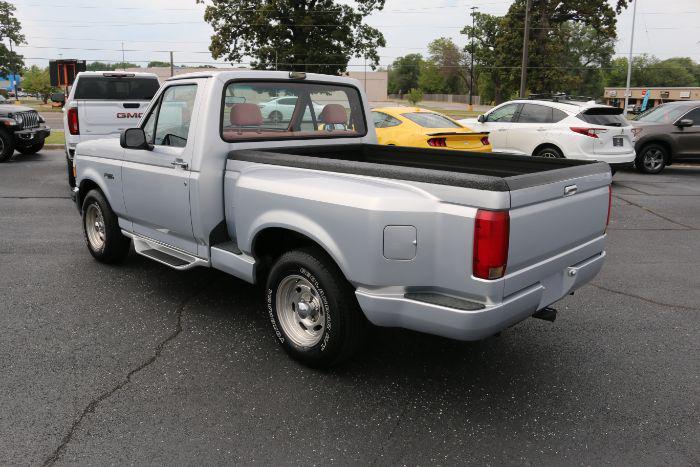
[504,168,611,295]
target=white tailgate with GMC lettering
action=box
[78,100,150,136]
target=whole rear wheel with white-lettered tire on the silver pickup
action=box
[265,248,367,368]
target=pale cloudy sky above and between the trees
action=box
[10,0,700,71]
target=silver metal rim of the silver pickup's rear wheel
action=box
[275,274,326,347]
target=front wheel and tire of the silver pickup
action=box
[82,190,131,264]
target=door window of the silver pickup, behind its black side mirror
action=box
[153,84,197,148]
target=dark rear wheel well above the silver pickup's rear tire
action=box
[252,227,333,284]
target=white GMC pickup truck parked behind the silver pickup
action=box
[63,71,160,187]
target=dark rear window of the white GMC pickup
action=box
[74,76,160,101]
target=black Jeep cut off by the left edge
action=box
[0,104,51,162]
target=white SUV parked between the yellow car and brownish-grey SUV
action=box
[459,100,635,167]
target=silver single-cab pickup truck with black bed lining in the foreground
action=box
[68,71,611,367]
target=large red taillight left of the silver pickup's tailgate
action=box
[472,209,510,279]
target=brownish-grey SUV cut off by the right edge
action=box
[632,101,700,174]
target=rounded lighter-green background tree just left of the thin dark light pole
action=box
[424,37,470,94]
